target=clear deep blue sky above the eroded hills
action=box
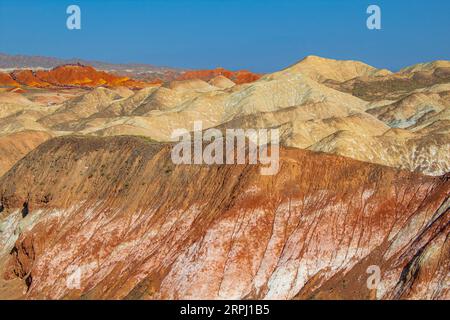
[0,0,450,72]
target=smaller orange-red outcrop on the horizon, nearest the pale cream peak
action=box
[176,68,261,84]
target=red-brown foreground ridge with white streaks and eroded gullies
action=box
[0,137,450,299]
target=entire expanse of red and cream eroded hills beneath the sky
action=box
[0,56,450,299]
